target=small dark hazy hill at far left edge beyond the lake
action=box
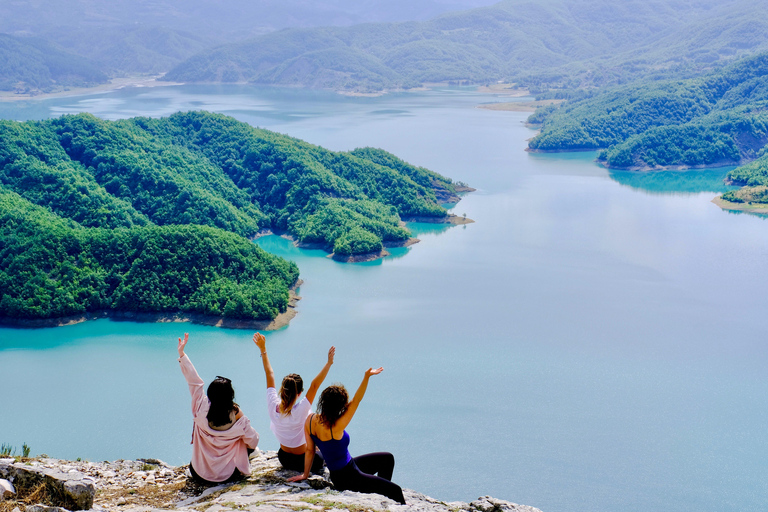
[0,34,107,92]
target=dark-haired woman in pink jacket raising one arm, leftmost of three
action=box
[178,333,259,484]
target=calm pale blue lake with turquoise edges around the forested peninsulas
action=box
[0,86,768,512]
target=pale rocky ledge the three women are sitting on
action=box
[0,450,541,512]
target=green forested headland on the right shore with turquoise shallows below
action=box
[528,53,768,210]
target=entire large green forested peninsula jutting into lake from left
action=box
[0,112,462,322]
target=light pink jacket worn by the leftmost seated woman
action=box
[179,354,259,482]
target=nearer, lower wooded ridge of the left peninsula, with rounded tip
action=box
[0,188,298,320]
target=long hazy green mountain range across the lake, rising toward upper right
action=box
[166,0,768,91]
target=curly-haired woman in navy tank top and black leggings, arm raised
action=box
[288,368,405,504]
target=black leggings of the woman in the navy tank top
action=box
[331,452,405,505]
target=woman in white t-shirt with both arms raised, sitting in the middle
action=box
[253,332,336,473]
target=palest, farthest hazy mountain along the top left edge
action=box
[0,0,494,42]
